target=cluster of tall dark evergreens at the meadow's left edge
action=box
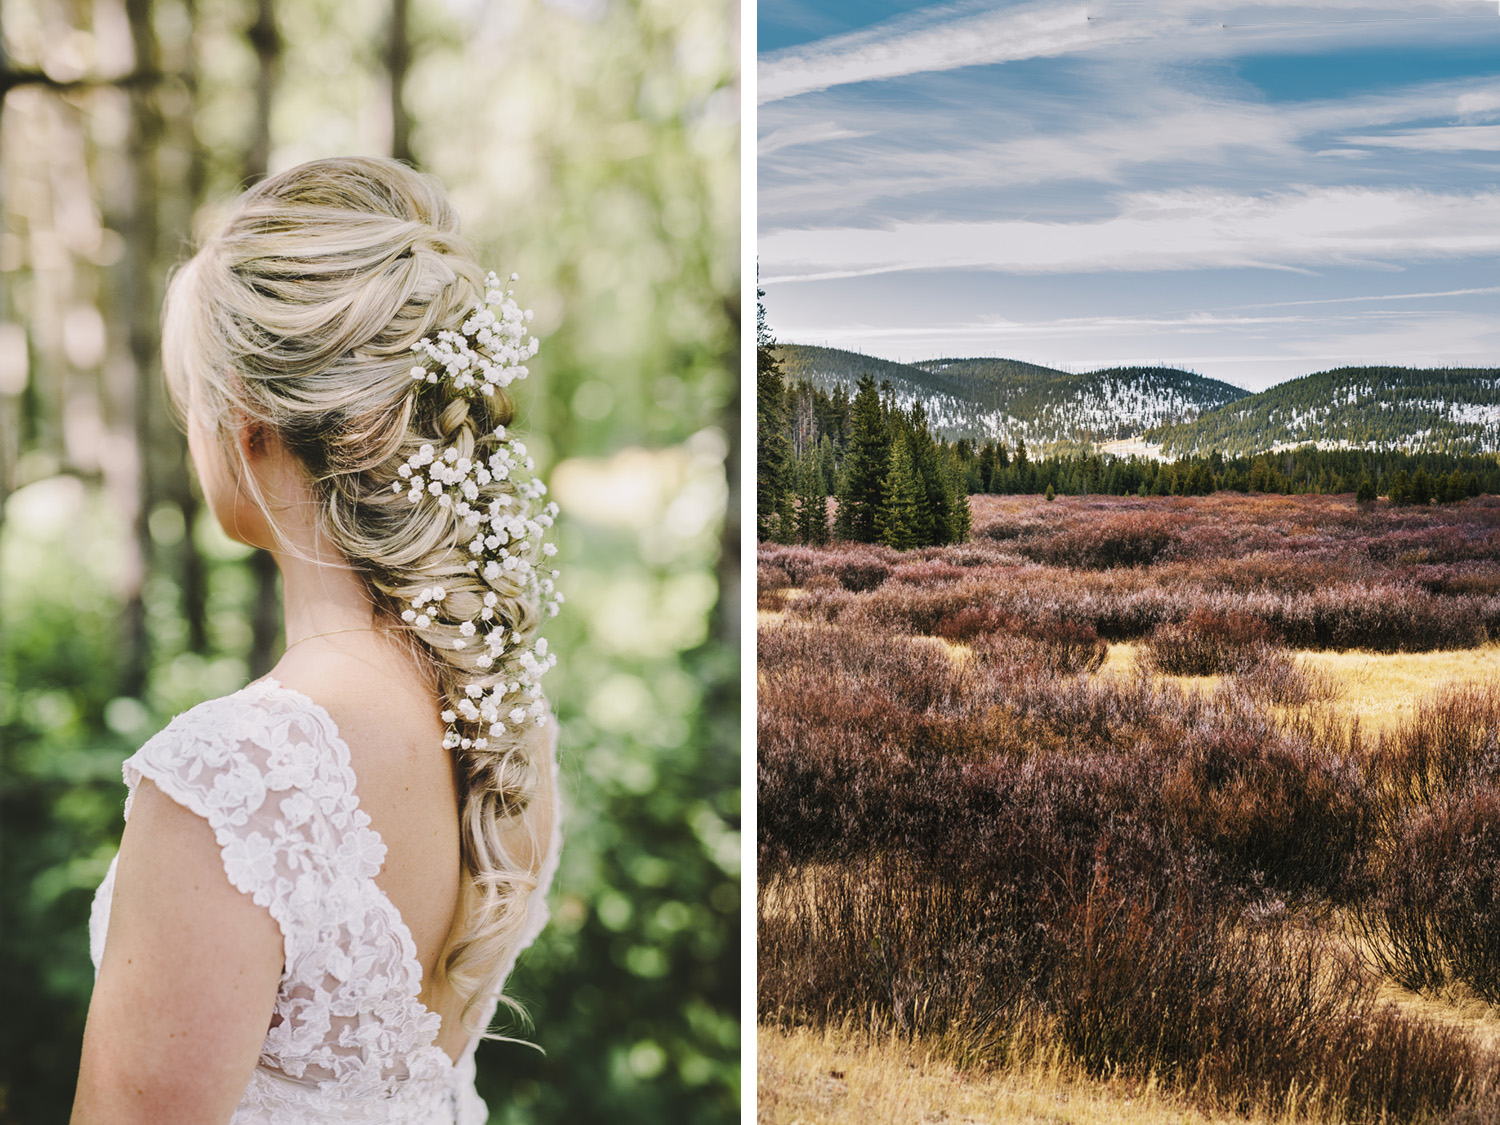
[756,308,972,551]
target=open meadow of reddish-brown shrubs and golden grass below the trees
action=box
[758,494,1500,1125]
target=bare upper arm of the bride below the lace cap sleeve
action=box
[72,780,284,1125]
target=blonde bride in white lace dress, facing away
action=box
[72,159,561,1125]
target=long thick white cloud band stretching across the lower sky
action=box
[761,188,1500,285]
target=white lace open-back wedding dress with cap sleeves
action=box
[89,680,560,1125]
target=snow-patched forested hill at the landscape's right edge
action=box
[1146,368,1500,456]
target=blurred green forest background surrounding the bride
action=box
[0,0,740,1125]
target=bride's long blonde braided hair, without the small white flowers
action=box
[162,158,555,1031]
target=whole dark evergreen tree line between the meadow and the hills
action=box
[756,308,1500,549]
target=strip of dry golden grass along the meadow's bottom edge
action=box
[756,1028,1326,1125]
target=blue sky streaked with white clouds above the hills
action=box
[756,0,1500,390]
